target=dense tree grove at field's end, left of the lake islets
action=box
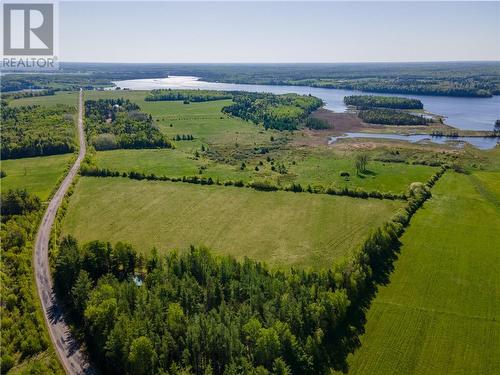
[222,92,323,130]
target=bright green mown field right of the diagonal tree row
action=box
[350,172,500,375]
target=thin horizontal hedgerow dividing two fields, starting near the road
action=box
[80,163,407,200]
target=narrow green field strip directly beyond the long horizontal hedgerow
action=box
[96,149,436,193]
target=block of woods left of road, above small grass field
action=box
[0,101,75,160]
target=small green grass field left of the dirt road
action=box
[0,154,73,200]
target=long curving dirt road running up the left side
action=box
[33,89,94,375]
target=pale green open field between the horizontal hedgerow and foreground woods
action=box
[63,177,402,268]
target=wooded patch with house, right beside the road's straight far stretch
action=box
[85,98,172,150]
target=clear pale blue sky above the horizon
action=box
[59,1,500,63]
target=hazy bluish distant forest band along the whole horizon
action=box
[1,62,500,97]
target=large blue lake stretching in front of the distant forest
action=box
[113,76,500,130]
